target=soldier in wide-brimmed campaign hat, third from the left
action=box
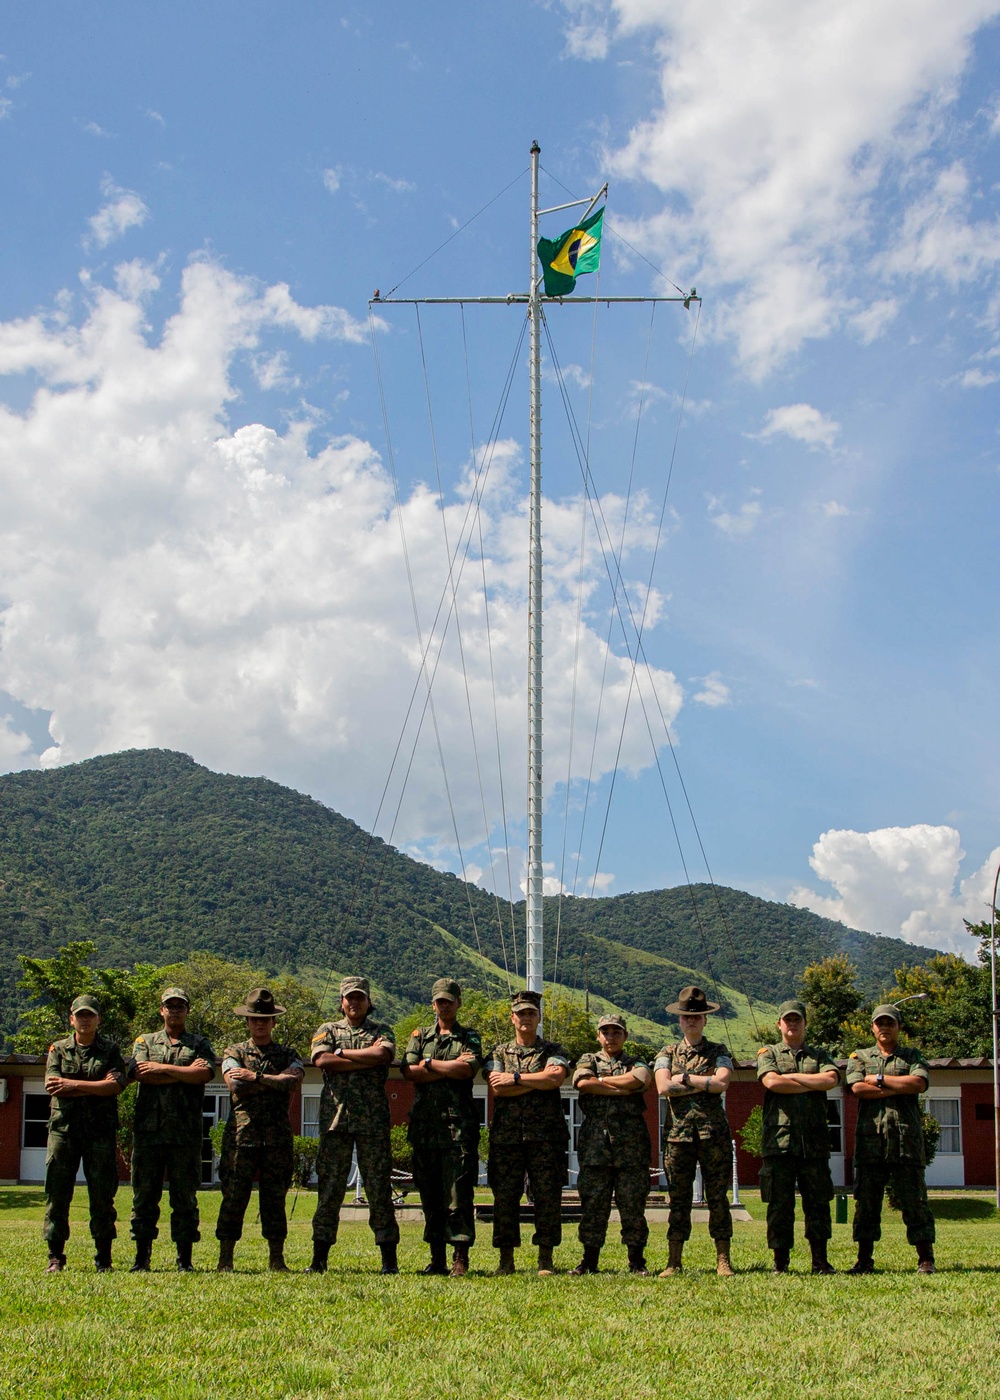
[216,987,299,1274]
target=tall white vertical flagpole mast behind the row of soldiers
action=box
[525,141,543,993]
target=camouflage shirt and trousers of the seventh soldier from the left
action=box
[573,1050,653,1249]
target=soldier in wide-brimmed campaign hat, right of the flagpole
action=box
[653,987,732,1278]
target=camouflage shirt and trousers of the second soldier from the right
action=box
[756,1042,840,1250]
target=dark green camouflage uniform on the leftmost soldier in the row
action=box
[42,1032,127,1254]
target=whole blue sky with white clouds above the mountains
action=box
[0,0,1000,951]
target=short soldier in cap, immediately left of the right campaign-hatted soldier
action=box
[571,1016,653,1274]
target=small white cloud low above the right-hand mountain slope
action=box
[789,825,1000,958]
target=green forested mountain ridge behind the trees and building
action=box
[0,749,930,1030]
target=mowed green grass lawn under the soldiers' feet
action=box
[0,1187,1000,1400]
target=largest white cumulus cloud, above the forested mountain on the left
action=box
[0,259,682,884]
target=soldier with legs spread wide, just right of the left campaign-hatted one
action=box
[310,977,399,1274]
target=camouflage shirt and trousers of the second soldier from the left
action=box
[132,1030,216,1245]
